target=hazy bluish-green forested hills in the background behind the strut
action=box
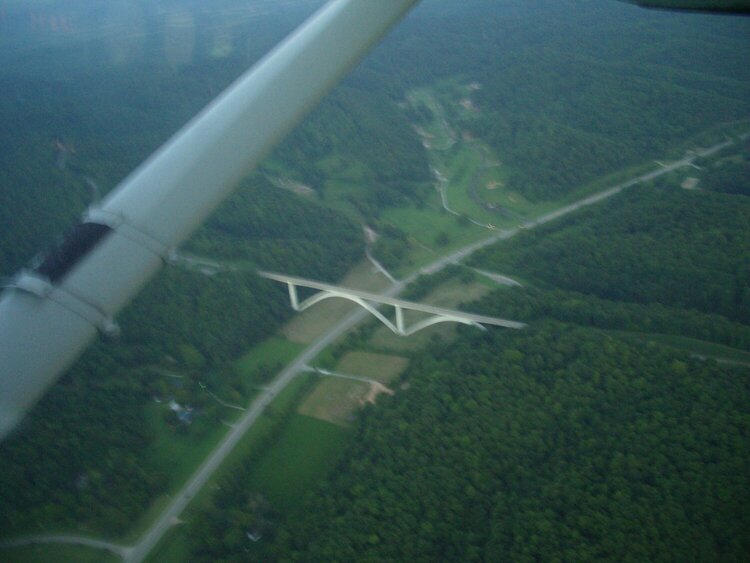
[0,0,750,275]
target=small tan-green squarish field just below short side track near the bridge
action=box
[298,377,370,426]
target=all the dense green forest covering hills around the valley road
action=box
[0,0,750,561]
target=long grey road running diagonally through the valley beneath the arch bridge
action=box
[2,137,733,563]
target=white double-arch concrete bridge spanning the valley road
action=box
[258,271,526,336]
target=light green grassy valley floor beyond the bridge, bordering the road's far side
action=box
[382,80,750,275]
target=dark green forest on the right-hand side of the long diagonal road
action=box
[185,148,750,561]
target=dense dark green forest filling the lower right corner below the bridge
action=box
[264,323,750,561]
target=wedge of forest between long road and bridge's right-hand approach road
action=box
[474,184,750,324]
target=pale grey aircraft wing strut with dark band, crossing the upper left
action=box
[0,0,418,439]
